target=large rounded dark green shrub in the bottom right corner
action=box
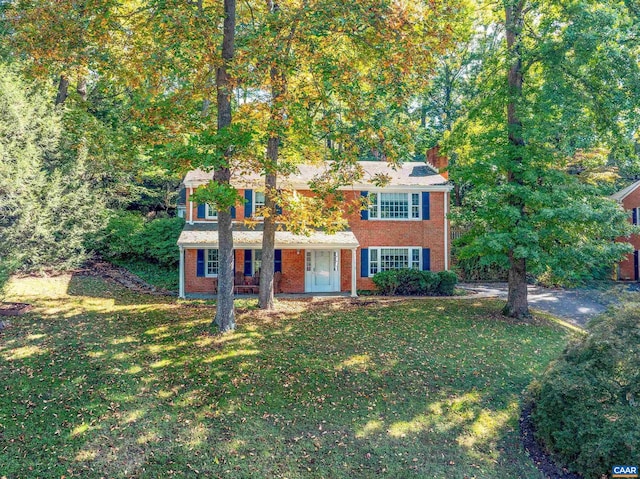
[531,309,640,478]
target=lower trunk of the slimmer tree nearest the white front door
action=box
[258,169,280,309]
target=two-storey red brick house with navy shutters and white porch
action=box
[178,161,452,298]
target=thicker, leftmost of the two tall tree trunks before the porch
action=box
[213,0,236,333]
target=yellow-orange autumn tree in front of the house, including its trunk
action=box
[239,0,460,309]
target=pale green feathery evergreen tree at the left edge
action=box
[0,66,104,288]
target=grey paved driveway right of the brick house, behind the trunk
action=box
[459,283,607,328]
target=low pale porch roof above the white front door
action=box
[178,223,360,249]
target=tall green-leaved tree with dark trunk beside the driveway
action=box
[450,0,640,318]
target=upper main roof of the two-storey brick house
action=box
[184,161,447,188]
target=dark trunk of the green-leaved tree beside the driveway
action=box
[503,0,530,319]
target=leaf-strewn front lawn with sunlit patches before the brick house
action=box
[0,276,571,479]
